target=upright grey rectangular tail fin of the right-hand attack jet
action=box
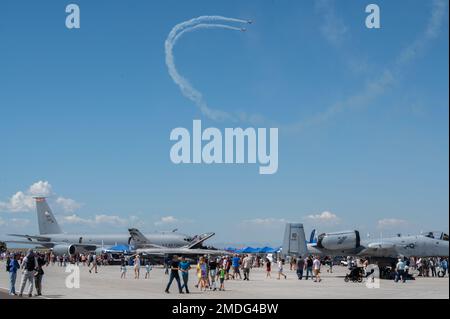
[282,223,308,257]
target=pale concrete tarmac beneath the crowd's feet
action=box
[0,262,449,299]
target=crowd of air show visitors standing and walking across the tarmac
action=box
[0,249,448,297]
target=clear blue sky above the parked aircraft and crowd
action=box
[0,0,449,244]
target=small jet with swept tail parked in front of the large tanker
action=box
[128,228,229,256]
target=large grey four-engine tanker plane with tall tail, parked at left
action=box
[6,197,214,255]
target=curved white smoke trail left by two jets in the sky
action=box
[165,16,248,121]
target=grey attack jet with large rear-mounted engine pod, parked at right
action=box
[283,224,449,263]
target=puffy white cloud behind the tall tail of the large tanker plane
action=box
[0,181,81,213]
